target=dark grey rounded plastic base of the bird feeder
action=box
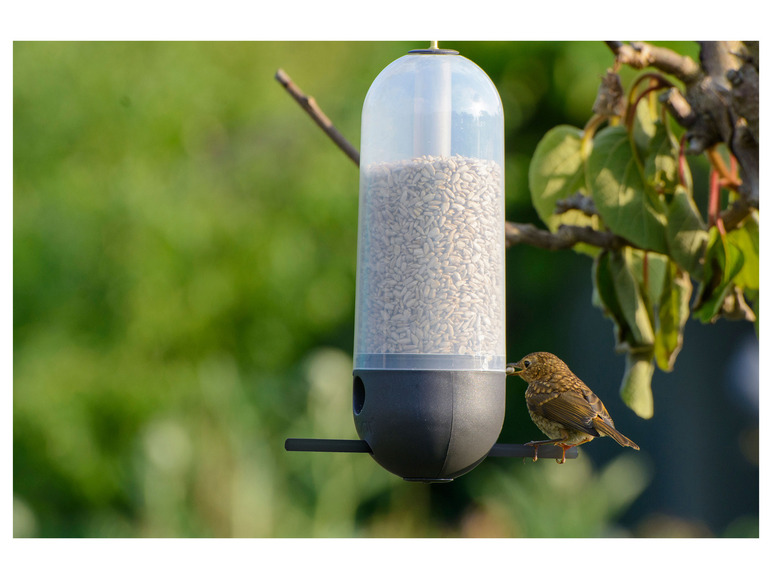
[353,370,506,482]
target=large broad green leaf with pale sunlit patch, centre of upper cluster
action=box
[585,127,667,253]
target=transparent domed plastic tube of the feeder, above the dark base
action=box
[354,50,506,372]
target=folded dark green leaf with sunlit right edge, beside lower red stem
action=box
[694,227,744,323]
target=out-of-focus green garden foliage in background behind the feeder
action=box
[13,42,757,537]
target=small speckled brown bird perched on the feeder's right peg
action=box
[507,352,640,464]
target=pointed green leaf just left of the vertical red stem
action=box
[667,185,708,279]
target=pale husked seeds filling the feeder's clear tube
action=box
[356,155,504,368]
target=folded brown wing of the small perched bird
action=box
[528,384,608,436]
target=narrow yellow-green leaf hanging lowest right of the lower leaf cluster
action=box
[654,262,692,372]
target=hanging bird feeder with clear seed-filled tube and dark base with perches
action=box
[287,47,576,482]
